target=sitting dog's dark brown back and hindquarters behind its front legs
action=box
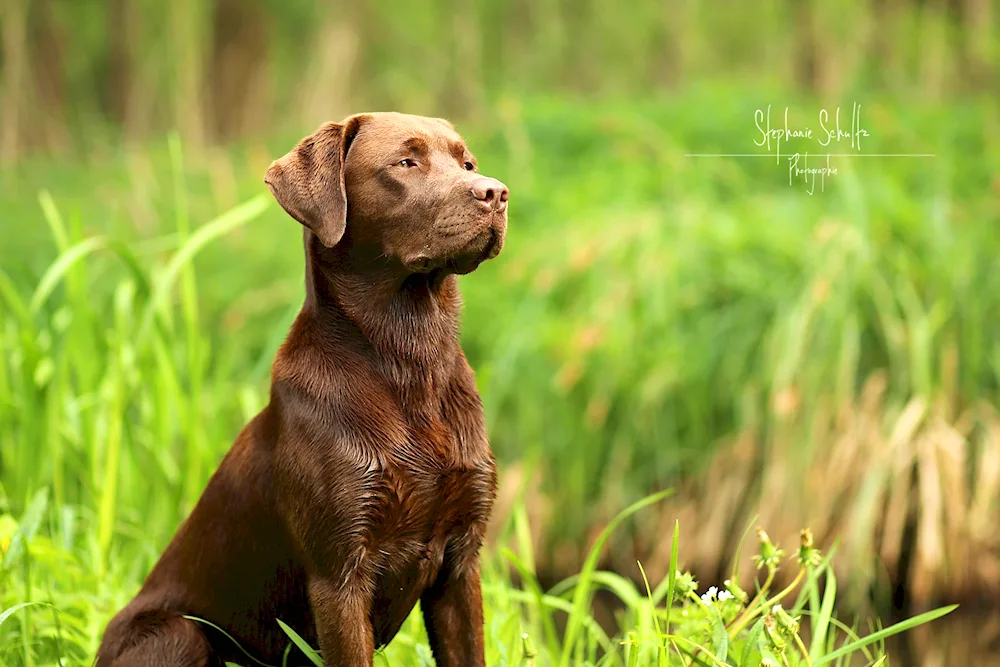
[97,407,316,667]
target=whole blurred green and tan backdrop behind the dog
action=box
[0,0,1000,664]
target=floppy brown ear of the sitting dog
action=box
[264,116,361,248]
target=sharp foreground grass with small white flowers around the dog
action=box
[0,488,954,667]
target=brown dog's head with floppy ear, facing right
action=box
[264,113,508,273]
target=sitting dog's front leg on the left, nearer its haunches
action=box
[309,577,375,667]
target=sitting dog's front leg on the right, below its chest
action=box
[420,555,486,667]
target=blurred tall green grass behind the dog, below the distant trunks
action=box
[0,88,1000,606]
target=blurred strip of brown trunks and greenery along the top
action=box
[0,0,1000,164]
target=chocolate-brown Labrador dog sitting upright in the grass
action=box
[97,113,507,667]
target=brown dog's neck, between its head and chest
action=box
[303,234,461,408]
